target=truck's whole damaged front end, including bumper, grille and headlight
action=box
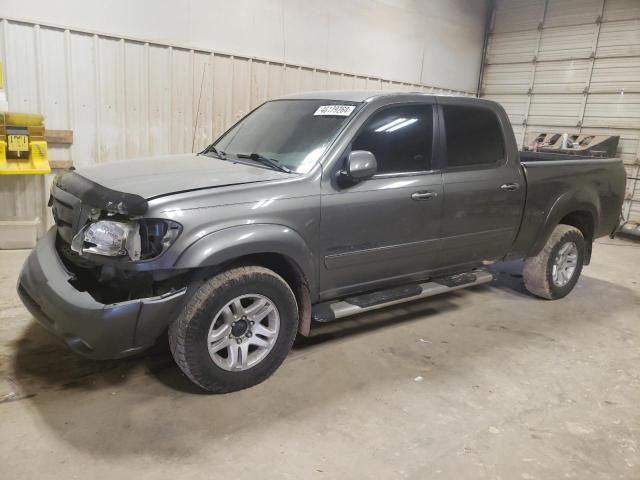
[18,172,189,359]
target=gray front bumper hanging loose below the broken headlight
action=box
[18,227,186,359]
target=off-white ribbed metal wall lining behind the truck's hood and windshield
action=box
[0,19,466,244]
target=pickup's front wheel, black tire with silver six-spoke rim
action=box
[169,266,298,393]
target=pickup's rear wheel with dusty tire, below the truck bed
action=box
[522,225,585,300]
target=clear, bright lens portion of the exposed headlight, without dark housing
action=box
[71,220,140,261]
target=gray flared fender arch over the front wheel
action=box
[175,223,318,292]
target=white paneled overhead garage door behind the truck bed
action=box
[481,0,640,221]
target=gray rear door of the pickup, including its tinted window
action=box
[438,98,525,266]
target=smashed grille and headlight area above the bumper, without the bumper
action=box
[49,172,186,301]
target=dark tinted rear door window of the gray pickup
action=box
[443,105,504,167]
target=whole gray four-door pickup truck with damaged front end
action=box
[18,92,625,392]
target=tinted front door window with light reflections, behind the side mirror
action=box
[351,105,433,173]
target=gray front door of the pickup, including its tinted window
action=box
[320,103,443,298]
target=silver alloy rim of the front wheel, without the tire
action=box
[207,294,280,372]
